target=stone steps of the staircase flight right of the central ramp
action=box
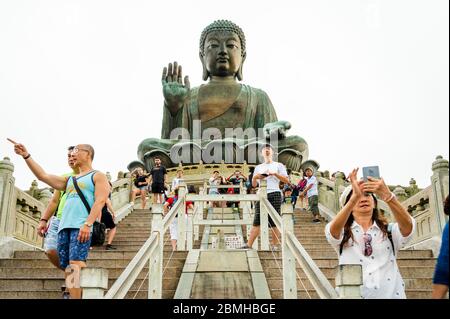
[259,209,436,299]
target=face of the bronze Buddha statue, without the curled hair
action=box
[203,31,243,77]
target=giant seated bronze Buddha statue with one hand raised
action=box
[128,20,318,171]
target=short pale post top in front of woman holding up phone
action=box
[336,265,363,299]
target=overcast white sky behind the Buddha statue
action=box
[0,0,449,188]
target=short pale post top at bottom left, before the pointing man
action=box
[80,268,108,299]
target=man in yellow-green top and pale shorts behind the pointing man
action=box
[37,146,79,270]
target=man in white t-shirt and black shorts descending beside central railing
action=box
[242,144,289,250]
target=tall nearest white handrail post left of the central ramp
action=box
[148,204,164,299]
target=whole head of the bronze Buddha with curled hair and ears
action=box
[200,20,246,81]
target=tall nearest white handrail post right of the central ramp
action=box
[281,198,298,299]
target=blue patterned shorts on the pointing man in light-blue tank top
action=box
[58,228,92,269]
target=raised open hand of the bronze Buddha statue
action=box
[161,62,191,115]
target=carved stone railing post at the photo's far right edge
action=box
[430,156,449,233]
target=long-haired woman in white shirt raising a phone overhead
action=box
[325,169,415,299]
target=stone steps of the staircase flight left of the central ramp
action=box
[0,209,187,299]
